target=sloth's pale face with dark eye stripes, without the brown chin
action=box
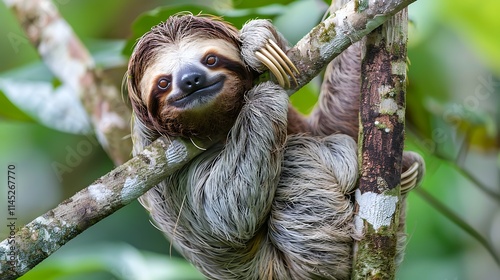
[140,38,244,113]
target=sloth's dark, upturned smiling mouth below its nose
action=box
[172,76,225,107]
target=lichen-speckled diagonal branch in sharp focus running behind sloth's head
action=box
[0,0,415,279]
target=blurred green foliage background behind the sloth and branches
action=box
[0,0,500,280]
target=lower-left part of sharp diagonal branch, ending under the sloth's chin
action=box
[0,137,210,279]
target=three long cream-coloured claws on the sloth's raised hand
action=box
[255,39,299,88]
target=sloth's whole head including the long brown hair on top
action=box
[128,15,253,138]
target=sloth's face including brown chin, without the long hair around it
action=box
[134,36,252,138]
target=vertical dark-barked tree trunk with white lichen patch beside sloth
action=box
[352,9,408,279]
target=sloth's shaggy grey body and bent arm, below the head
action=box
[141,82,357,279]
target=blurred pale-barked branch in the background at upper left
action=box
[4,0,132,165]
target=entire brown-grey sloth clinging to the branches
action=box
[128,15,421,279]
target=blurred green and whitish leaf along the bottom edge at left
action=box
[20,244,204,280]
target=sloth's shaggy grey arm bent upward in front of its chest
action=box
[197,82,288,243]
